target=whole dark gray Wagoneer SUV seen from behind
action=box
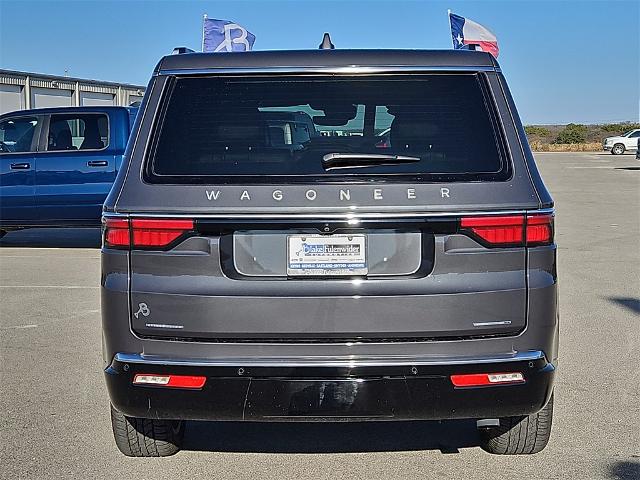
[102,50,558,456]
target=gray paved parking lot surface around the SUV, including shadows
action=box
[0,153,640,480]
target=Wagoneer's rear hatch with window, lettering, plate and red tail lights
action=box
[106,72,551,342]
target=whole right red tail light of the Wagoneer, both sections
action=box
[460,213,553,247]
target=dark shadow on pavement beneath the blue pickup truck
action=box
[0,228,101,248]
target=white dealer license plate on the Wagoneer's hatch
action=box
[287,235,368,276]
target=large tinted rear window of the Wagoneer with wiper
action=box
[145,74,510,184]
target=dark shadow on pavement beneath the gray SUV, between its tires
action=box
[182,420,479,453]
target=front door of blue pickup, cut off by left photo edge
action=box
[0,115,42,226]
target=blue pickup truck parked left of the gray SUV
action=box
[0,107,138,237]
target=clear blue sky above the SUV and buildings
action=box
[0,0,640,124]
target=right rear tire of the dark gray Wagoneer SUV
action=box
[480,394,553,455]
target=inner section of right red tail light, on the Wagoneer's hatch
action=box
[460,215,524,245]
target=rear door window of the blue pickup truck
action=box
[47,113,109,151]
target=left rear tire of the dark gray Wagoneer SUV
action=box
[111,406,184,457]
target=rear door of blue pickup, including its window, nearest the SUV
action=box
[35,112,116,225]
